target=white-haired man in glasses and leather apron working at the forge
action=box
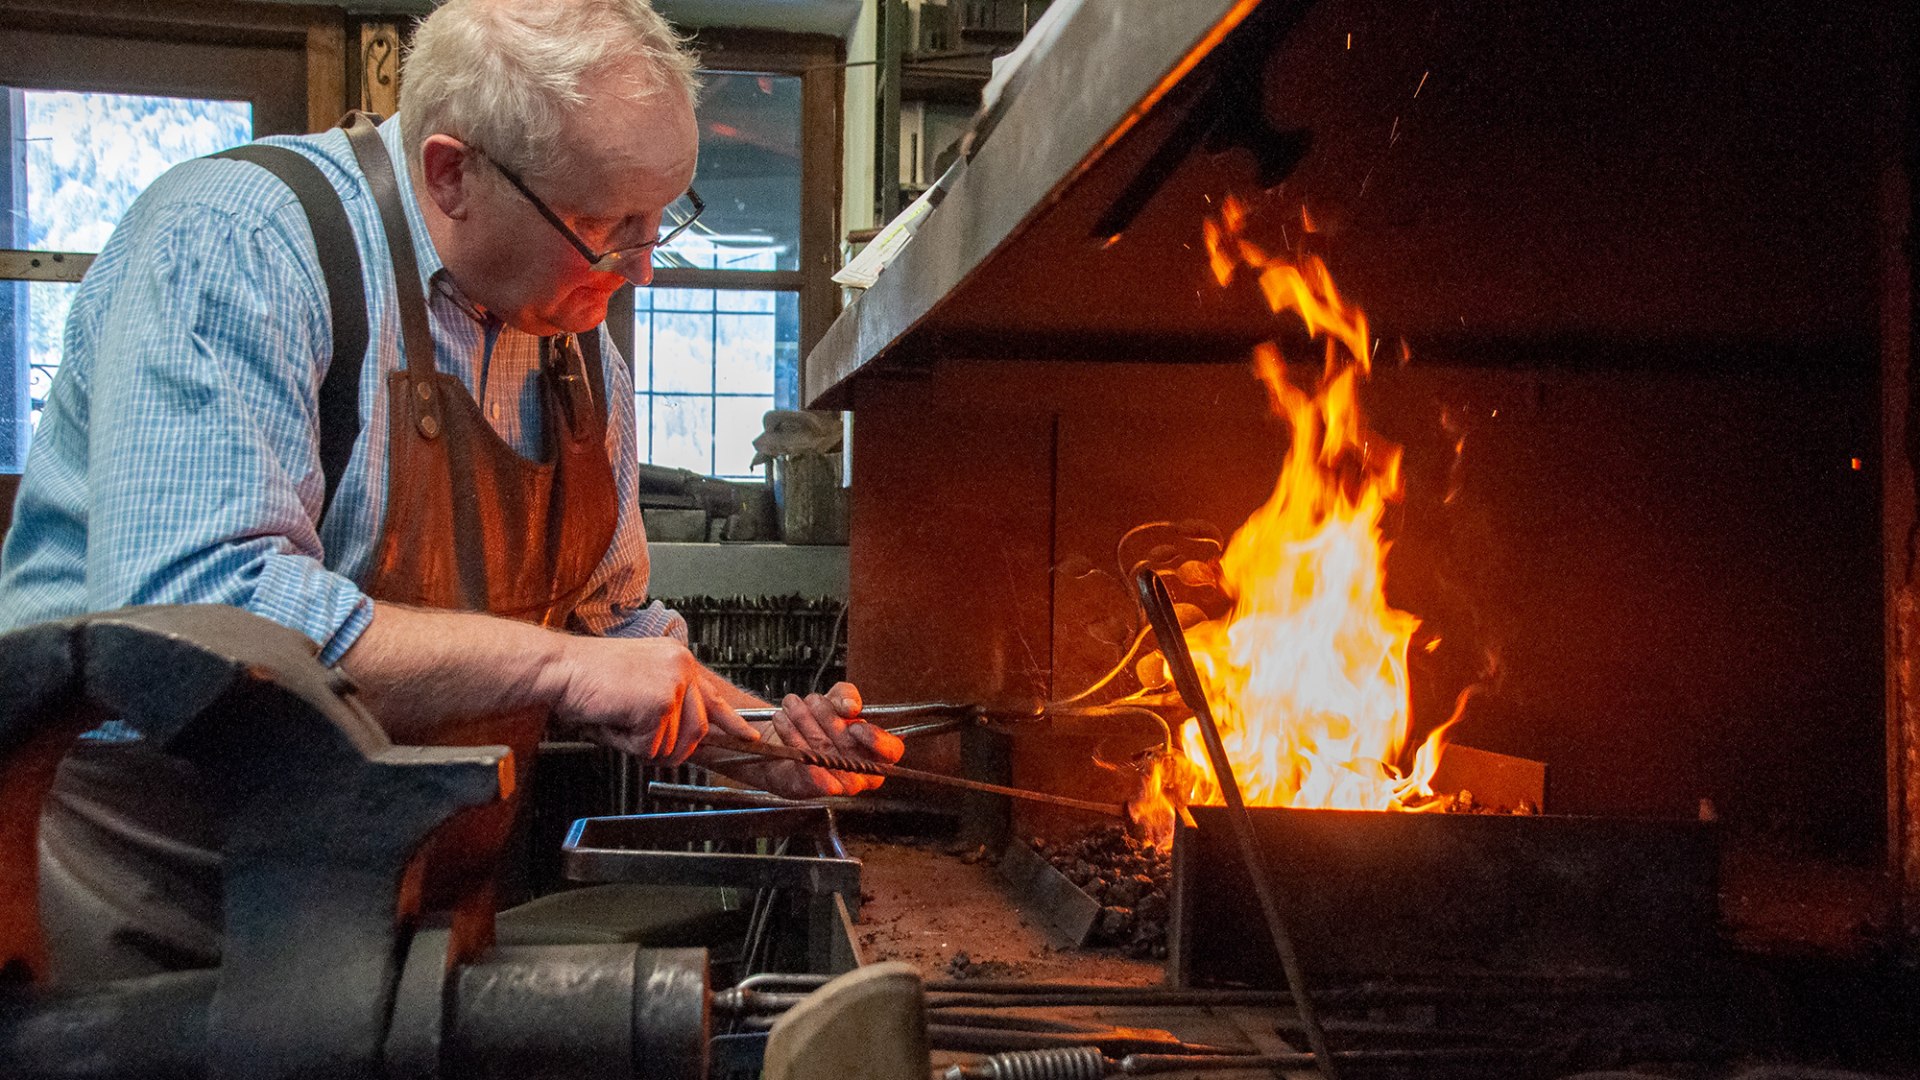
[0,0,900,978]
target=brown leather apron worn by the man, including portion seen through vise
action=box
[40,117,618,982]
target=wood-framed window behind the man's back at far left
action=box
[0,0,322,474]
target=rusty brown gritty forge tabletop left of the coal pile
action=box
[847,840,1164,986]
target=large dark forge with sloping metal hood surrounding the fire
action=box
[804,0,1920,1060]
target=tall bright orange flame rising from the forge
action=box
[1179,198,1444,809]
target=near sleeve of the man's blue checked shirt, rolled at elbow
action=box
[68,163,372,663]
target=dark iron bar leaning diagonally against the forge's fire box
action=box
[1133,567,1338,1080]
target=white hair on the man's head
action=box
[399,0,699,177]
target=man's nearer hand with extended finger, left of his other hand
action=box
[553,638,760,765]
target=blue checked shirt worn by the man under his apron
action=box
[0,119,685,663]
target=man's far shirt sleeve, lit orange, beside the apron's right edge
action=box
[572,329,687,644]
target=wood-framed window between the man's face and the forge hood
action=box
[622,35,839,479]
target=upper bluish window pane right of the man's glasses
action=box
[655,71,801,269]
